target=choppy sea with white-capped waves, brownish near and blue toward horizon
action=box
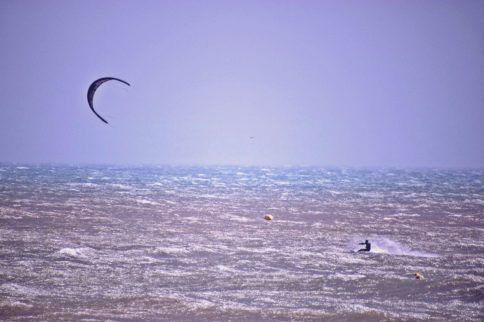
[0,164,484,321]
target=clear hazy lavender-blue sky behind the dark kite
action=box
[0,0,484,168]
